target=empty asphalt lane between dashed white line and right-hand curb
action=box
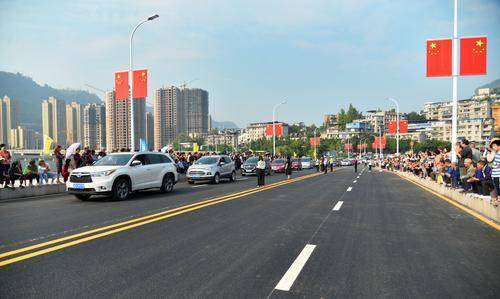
[286,171,500,298]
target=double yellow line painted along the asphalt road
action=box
[0,173,320,267]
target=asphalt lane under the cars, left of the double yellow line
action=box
[0,171,318,251]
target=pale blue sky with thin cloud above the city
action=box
[0,0,500,126]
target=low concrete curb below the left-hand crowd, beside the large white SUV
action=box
[0,174,186,201]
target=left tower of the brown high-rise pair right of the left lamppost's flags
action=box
[153,86,184,150]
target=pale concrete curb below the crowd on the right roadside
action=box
[397,172,500,223]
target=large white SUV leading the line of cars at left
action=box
[66,152,179,200]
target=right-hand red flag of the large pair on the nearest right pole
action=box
[460,36,487,76]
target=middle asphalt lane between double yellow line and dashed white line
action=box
[0,171,352,298]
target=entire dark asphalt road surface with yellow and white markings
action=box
[0,167,500,298]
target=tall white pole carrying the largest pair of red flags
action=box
[451,0,458,162]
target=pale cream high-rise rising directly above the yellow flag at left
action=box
[42,97,67,146]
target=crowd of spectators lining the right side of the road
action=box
[380,138,500,206]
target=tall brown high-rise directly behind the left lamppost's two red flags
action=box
[105,91,146,151]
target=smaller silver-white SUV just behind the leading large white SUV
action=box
[186,155,236,184]
